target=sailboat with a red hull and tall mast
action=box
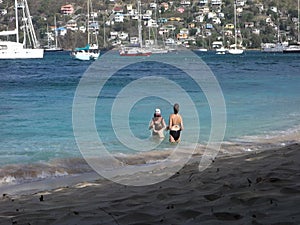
[119,0,152,56]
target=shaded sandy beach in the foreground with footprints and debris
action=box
[0,144,300,225]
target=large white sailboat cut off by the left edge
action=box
[0,0,44,59]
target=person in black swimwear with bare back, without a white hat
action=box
[169,103,183,143]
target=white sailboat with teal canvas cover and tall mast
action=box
[71,0,100,61]
